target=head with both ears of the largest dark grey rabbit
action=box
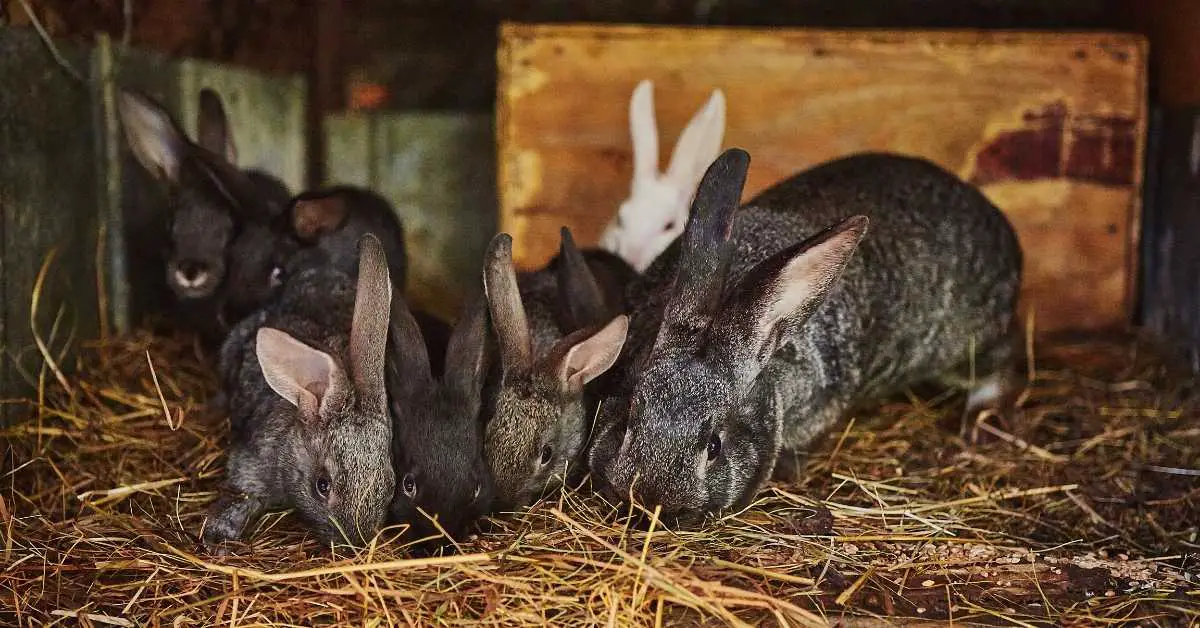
[592,149,866,522]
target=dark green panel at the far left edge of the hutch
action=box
[0,29,100,414]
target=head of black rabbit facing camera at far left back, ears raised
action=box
[118,89,279,299]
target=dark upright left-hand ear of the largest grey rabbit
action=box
[659,149,750,342]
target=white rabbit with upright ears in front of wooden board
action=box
[600,80,725,273]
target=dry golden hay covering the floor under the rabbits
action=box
[0,326,1200,626]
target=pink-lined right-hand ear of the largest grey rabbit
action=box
[709,216,868,385]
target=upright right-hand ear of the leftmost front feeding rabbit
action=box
[350,233,392,413]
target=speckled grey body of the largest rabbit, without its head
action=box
[622,152,1022,441]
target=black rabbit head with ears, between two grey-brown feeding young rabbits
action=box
[388,286,492,549]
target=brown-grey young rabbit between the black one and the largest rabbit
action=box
[484,227,629,509]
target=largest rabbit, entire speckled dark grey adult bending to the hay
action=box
[588,149,1022,525]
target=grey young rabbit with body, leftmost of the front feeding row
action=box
[202,235,396,551]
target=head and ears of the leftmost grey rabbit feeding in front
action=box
[256,237,396,545]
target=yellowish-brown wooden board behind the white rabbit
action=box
[497,24,1146,331]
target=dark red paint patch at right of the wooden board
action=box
[970,102,1138,186]
